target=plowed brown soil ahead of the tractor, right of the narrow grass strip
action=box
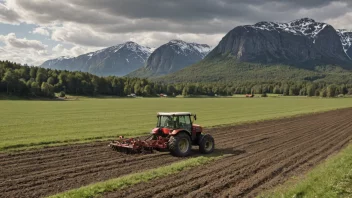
[104,109,352,197]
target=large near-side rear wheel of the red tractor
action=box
[168,133,192,157]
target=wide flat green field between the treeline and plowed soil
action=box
[0,97,352,150]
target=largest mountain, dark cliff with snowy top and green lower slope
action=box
[155,18,352,82]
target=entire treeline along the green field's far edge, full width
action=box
[0,61,352,97]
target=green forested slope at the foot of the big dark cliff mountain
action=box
[157,56,352,83]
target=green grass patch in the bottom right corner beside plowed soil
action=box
[258,144,352,198]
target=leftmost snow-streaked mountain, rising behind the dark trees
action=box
[41,41,152,76]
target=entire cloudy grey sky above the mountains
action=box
[0,0,352,65]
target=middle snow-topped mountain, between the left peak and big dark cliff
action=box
[127,40,210,77]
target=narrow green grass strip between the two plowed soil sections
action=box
[50,155,224,198]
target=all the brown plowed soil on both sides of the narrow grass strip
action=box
[0,108,352,197]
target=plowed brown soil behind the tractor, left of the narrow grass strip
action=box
[0,142,180,197]
